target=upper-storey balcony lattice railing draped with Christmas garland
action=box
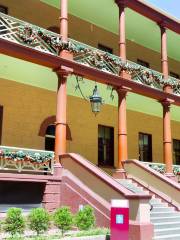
[0,13,180,95]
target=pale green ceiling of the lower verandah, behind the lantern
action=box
[0,54,180,122]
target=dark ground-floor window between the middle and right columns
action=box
[139,133,152,162]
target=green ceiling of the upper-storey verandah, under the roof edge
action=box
[40,0,180,61]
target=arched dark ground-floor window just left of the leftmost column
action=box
[45,124,55,151]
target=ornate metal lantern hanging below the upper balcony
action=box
[89,85,102,115]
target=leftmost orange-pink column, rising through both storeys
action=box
[54,0,71,171]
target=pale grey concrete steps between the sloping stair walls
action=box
[117,179,180,240]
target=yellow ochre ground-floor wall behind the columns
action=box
[0,79,180,165]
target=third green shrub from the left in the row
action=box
[54,206,73,235]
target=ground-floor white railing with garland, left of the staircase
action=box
[0,146,54,173]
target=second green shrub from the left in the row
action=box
[28,208,50,235]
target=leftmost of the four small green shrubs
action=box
[4,208,25,236]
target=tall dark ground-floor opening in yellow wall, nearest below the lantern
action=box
[98,125,114,166]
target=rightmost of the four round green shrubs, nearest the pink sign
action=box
[75,205,95,230]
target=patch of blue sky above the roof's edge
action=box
[146,0,180,19]
